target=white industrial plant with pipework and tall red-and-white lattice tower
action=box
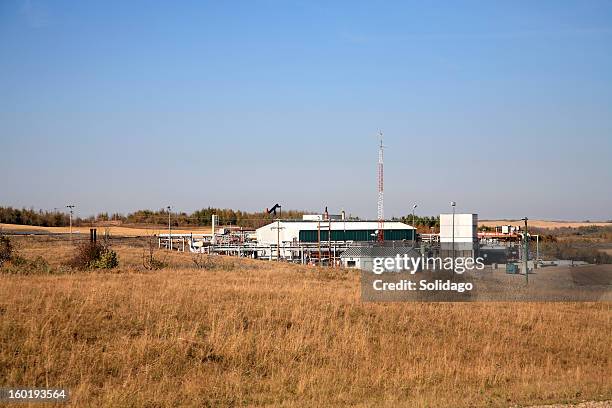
[158,133,538,270]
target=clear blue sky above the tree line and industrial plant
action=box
[0,0,612,220]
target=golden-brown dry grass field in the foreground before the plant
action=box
[0,237,612,407]
